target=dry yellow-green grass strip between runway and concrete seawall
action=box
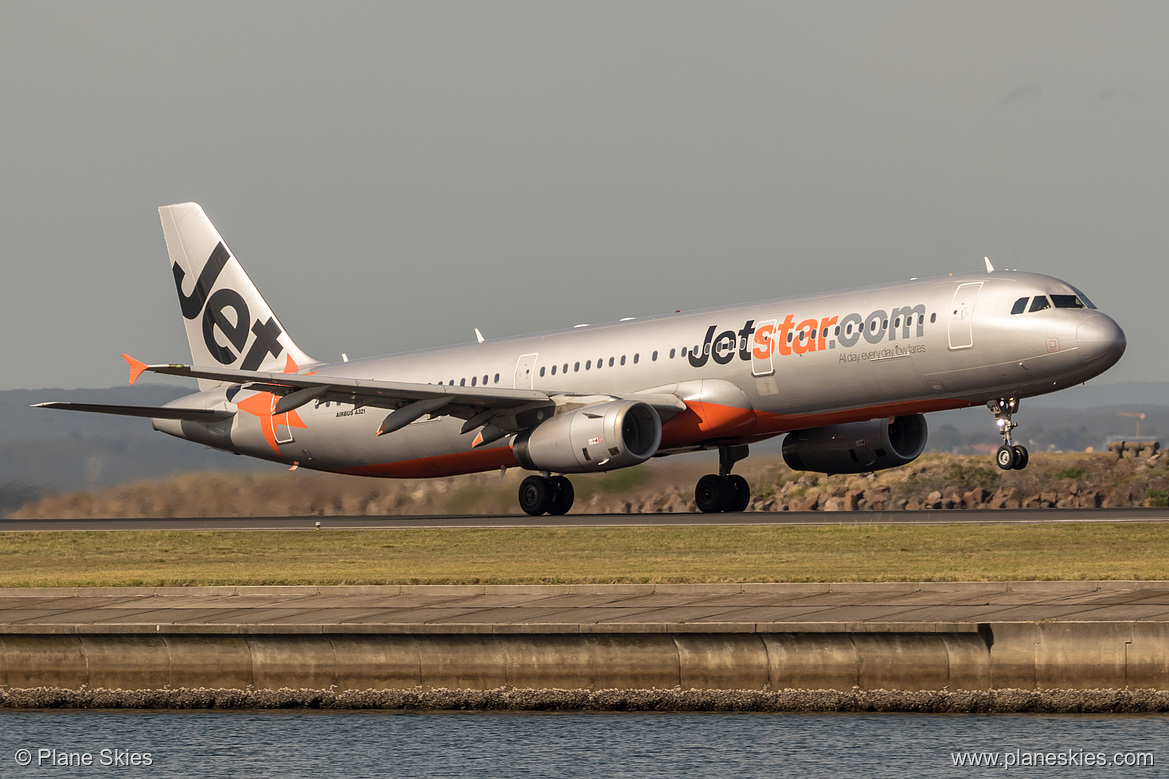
[0,523,1169,587]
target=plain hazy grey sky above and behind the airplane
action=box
[0,0,1169,388]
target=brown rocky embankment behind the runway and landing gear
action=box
[9,442,1169,519]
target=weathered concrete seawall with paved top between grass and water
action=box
[0,581,1169,691]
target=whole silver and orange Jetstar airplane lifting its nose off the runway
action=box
[41,204,1126,516]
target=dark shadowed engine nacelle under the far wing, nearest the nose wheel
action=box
[783,414,927,474]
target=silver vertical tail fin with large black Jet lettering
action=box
[158,202,319,390]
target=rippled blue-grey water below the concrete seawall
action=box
[0,711,1169,779]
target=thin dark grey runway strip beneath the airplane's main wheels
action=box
[0,509,1169,532]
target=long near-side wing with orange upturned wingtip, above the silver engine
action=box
[124,356,685,435]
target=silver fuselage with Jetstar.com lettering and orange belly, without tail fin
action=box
[153,271,1125,477]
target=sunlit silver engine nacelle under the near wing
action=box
[512,400,662,474]
